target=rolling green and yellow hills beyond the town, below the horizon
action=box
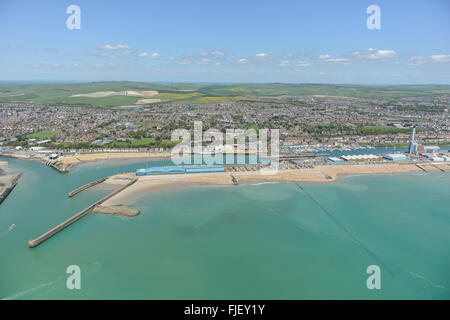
[0,81,450,108]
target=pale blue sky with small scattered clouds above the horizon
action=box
[0,0,450,84]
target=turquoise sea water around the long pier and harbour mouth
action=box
[0,159,450,299]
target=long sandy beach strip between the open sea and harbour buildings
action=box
[103,163,450,211]
